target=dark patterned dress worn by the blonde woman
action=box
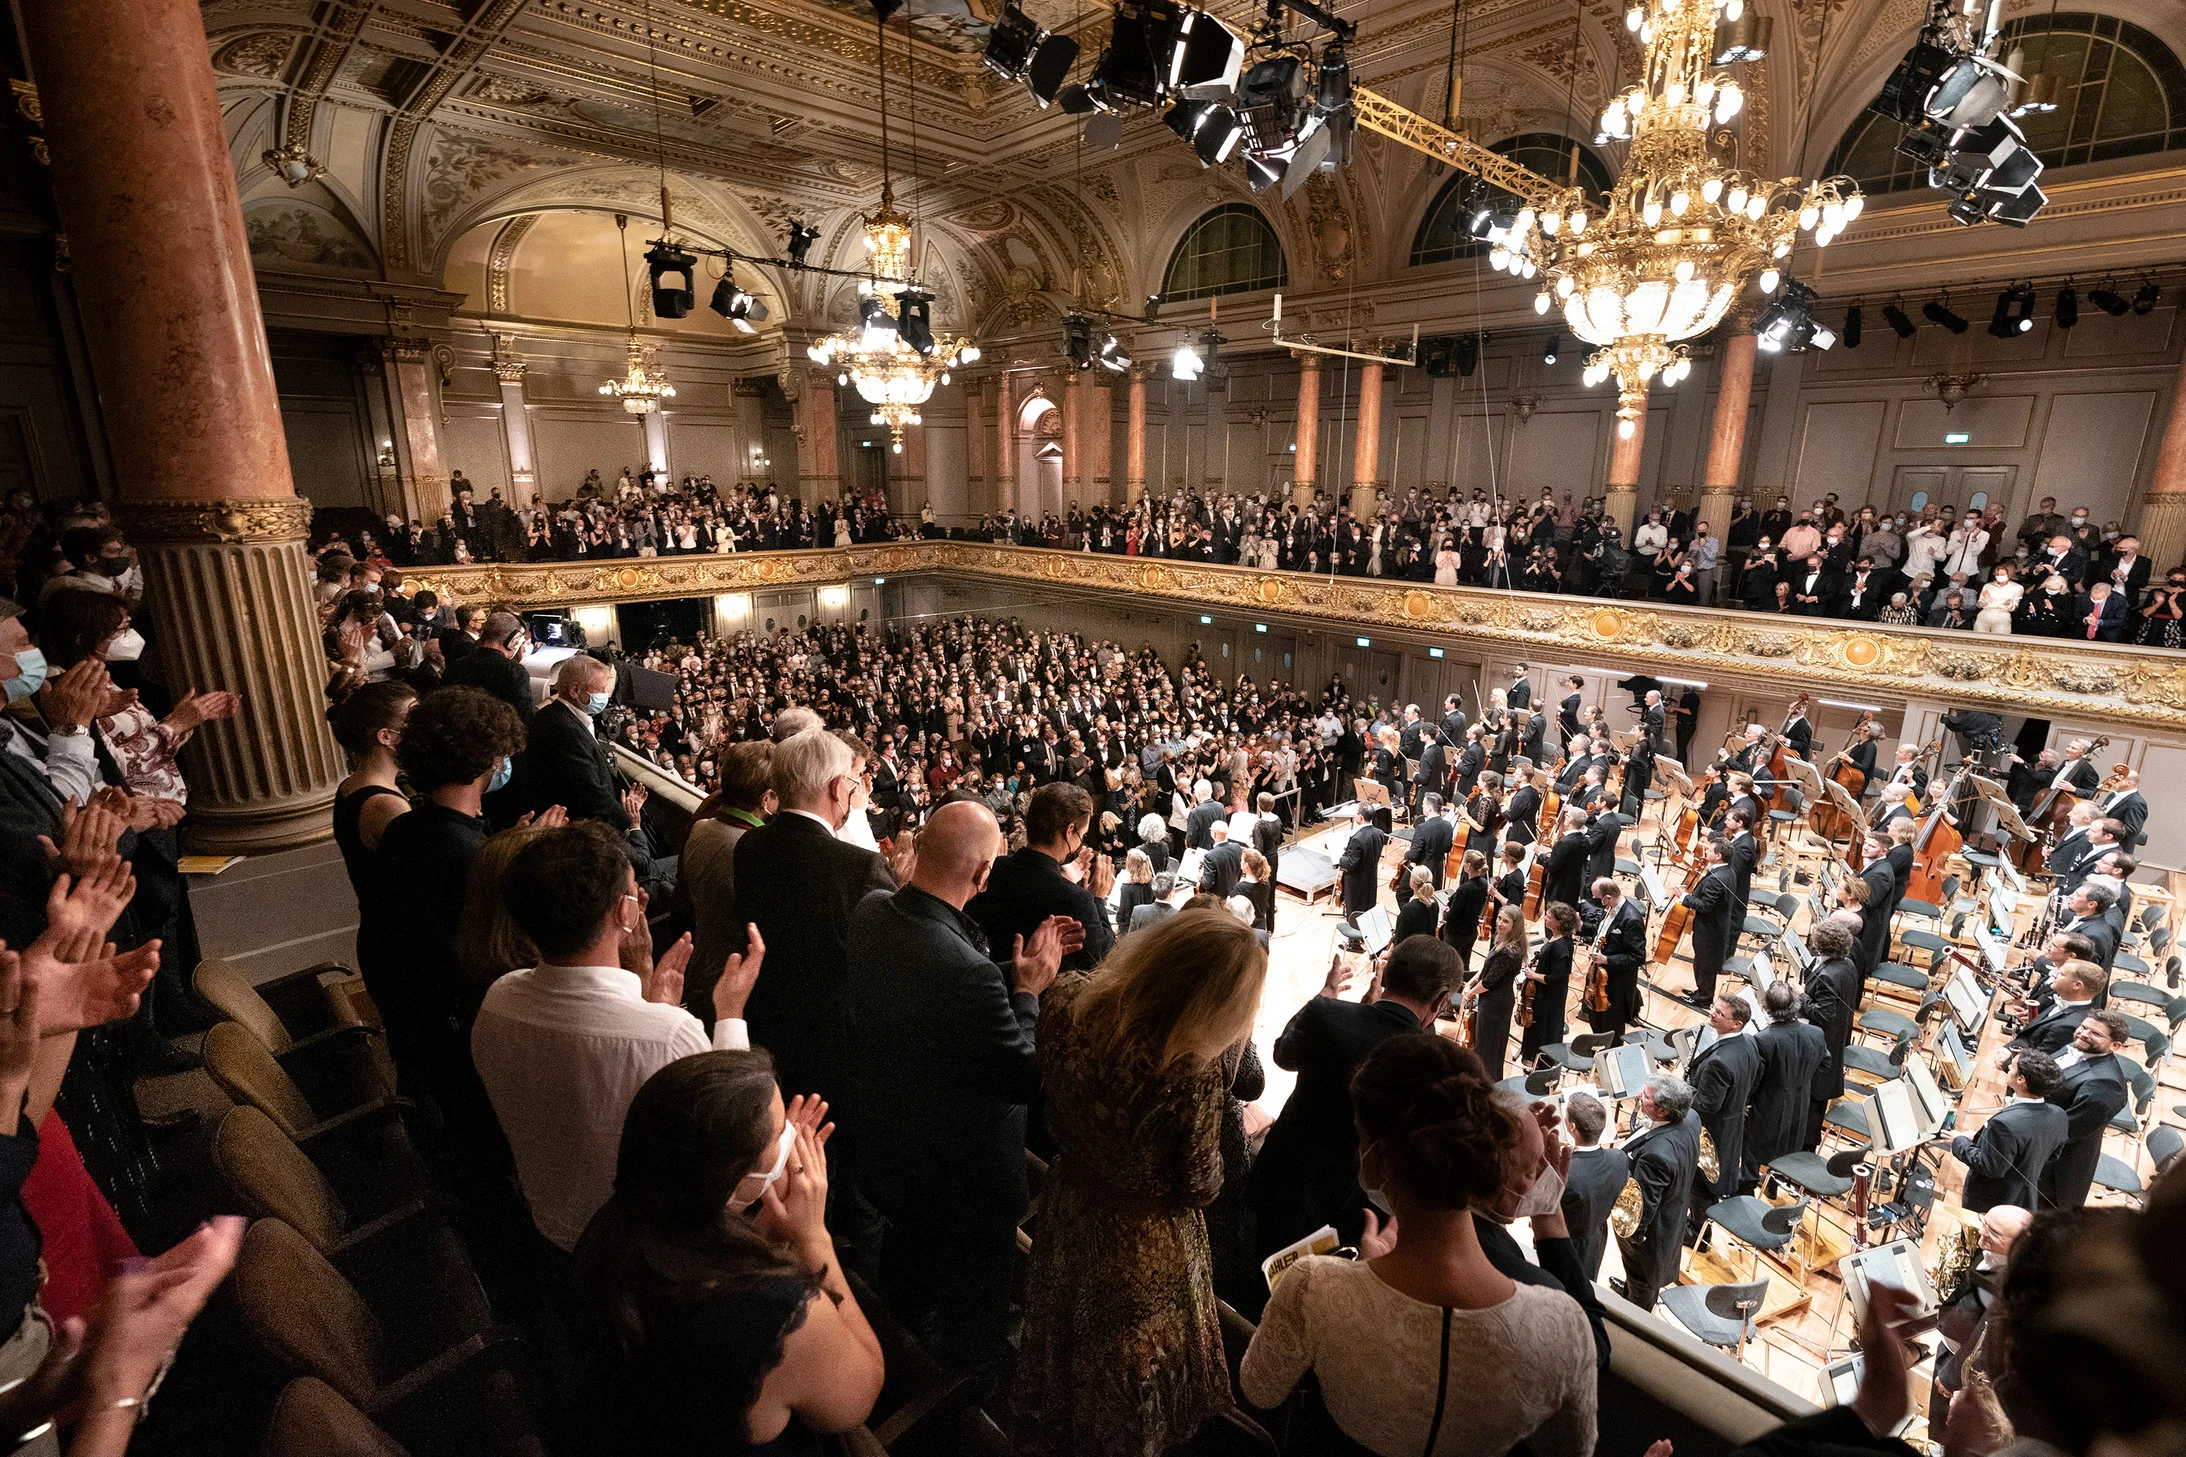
[1016,972,1233,1457]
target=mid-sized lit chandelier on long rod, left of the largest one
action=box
[804,7,979,454]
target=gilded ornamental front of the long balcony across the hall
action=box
[411,542,2186,730]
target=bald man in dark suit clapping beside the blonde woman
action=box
[828,802,1084,1365]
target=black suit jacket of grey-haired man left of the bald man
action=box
[737,810,896,1097]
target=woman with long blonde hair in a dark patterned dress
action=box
[1016,909,1268,1457]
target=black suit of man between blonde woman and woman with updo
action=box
[1246,996,1421,1254]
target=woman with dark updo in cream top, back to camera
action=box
[1237,1033,1598,1457]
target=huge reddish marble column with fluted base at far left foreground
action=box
[20,0,345,854]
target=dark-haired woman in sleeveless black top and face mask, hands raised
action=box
[568,1051,883,1455]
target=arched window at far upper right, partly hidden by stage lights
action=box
[1830,13,2186,192]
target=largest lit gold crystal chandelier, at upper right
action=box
[1486,0,1865,437]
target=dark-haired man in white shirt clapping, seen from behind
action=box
[470,821,767,1249]
